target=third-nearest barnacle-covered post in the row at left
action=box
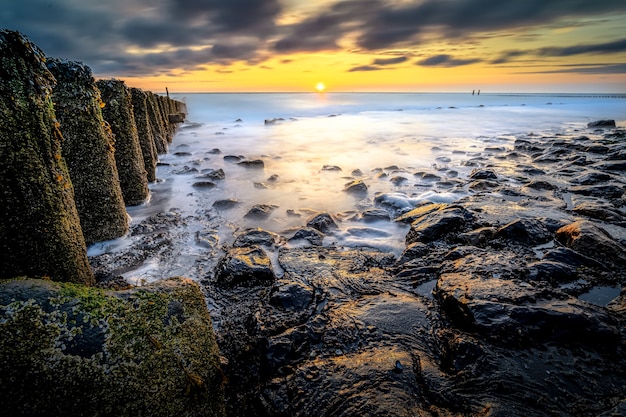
[96,79,149,206]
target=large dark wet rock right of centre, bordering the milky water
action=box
[405,206,473,245]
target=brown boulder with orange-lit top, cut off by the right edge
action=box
[556,220,626,266]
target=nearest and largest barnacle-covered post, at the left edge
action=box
[0,30,94,284]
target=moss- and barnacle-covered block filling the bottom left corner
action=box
[0,277,224,416]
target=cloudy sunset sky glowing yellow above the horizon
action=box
[0,0,626,93]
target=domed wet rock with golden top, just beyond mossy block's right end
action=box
[216,246,275,287]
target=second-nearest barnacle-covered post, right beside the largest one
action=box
[47,59,128,244]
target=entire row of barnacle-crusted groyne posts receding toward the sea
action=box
[0,30,185,285]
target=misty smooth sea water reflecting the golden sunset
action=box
[90,93,626,282]
